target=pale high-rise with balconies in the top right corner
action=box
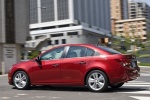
[129,0,150,20]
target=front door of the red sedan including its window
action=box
[32,47,64,83]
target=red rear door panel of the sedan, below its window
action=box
[61,57,92,83]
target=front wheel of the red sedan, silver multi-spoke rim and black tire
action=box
[13,71,30,90]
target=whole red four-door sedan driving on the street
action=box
[8,44,140,92]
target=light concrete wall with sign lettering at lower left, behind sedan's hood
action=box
[0,44,21,74]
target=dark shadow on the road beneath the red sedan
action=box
[13,86,148,93]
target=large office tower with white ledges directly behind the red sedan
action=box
[26,0,111,50]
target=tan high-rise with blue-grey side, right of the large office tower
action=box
[110,0,128,34]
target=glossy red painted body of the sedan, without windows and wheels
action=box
[8,44,140,86]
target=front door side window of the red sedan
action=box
[41,47,64,60]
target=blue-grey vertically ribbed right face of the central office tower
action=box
[73,0,111,31]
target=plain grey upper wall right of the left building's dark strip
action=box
[15,0,29,44]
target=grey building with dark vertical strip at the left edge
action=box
[0,0,29,73]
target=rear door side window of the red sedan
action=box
[66,46,86,58]
